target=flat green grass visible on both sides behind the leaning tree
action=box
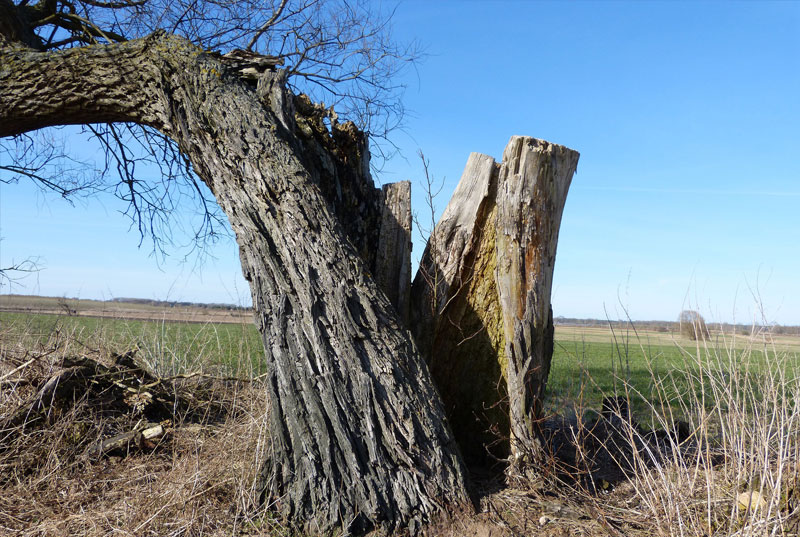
[0,313,800,418]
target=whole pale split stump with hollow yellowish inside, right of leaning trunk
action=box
[411,136,578,470]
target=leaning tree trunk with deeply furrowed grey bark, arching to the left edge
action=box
[0,33,469,533]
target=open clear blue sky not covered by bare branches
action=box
[0,1,800,324]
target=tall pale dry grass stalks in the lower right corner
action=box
[632,334,800,536]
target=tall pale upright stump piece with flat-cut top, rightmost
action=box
[496,136,579,470]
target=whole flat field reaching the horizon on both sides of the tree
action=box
[0,295,800,411]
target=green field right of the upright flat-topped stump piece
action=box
[547,327,800,415]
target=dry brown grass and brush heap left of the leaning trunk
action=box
[0,320,274,536]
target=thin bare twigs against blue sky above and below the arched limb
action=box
[0,0,419,255]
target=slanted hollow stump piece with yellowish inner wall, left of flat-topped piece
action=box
[411,153,508,462]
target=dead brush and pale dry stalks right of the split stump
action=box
[552,322,800,537]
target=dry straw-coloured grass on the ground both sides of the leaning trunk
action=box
[0,312,800,537]
